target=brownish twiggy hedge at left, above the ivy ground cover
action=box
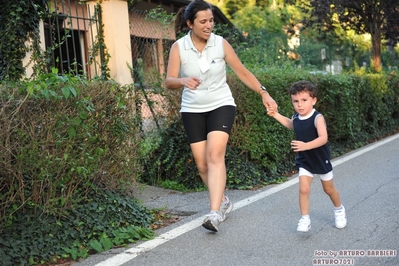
[0,71,144,235]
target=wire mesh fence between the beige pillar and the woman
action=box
[129,9,181,133]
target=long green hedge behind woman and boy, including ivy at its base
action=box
[142,66,399,189]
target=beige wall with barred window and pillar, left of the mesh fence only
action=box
[25,0,133,84]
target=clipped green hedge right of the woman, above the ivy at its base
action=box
[230,68,399,170]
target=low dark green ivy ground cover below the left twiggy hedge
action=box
[0,190,154,266]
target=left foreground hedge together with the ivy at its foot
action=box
[0,70,154,265]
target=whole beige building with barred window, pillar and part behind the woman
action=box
[25,0,232,84]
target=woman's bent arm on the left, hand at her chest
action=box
[165,42,201,90]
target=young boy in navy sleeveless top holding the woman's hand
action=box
[268,80,346,232]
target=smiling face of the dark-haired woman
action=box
[187,9,215,40]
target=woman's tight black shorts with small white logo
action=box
[181,105,236,143]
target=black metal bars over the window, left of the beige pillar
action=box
[44,0,102,78]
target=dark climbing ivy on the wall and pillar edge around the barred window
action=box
[0,0,110,81]
